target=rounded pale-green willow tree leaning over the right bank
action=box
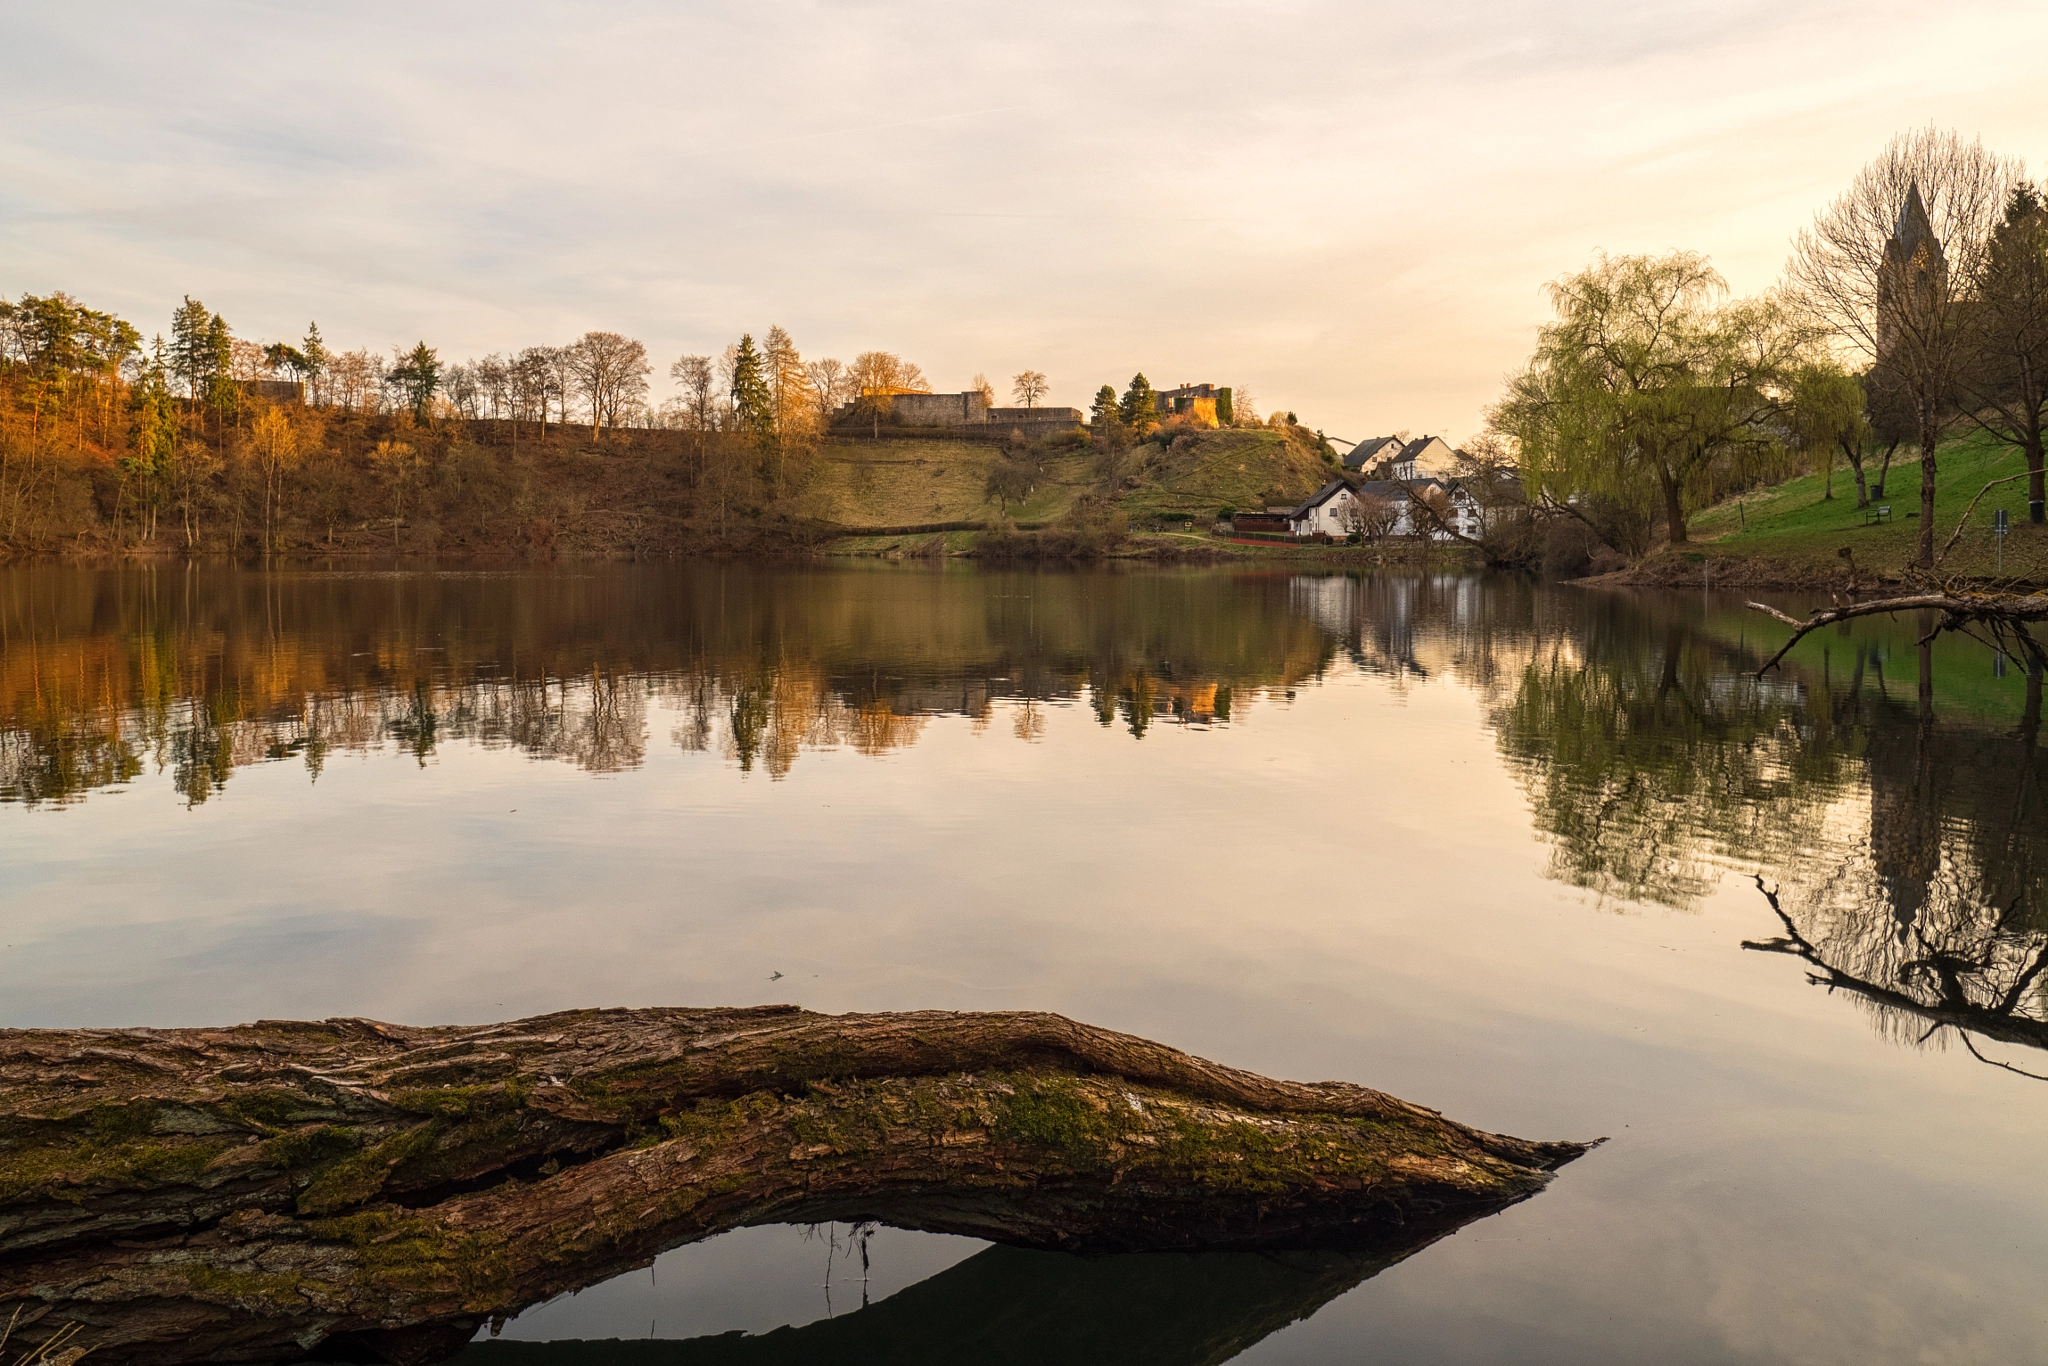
[1491,252,1798,545]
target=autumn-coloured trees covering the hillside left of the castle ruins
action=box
[0,293,950,551]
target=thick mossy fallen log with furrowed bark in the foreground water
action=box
[0,1006,1587,1366]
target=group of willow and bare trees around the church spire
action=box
[1489,129,2048,567]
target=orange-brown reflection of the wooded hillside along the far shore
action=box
[0,565,1333,803]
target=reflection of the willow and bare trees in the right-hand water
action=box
[1493,596,2048,1075]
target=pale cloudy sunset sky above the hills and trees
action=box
[0,0,2048,438]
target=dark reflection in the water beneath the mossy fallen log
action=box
[455,1233,1444,1366]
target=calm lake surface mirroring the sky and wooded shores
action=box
[0,565,2048,1366]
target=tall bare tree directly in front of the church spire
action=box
[1788,127,2019,569]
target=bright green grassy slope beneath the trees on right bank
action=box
[1692,432,2048,582]
